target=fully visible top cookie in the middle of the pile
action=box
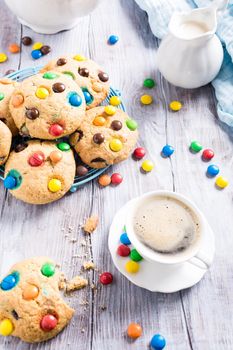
[9,72,86,140]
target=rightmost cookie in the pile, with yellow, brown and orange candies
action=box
[70,106,138,168]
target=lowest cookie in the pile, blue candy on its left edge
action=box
[4,140,75,204]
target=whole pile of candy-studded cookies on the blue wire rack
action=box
[0,55,138,204]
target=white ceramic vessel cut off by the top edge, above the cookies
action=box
[5,0,101,34]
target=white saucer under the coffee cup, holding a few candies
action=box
[108,199,215,293]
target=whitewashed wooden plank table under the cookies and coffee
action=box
[0,0,233,350]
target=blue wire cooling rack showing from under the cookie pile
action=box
[0,66,125,192]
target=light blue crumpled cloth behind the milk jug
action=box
[135,0,233,127]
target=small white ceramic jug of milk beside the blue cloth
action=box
[157,0,228,89]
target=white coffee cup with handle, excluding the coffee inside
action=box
[126,191,211,269]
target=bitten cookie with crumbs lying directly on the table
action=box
[0,257,74,343]
